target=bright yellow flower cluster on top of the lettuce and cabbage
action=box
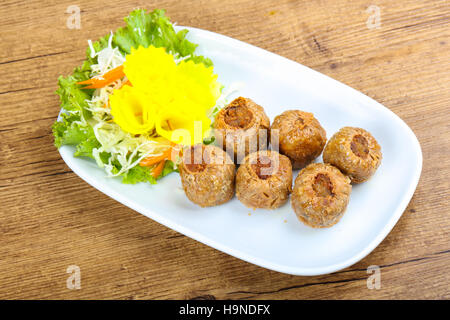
[109,46,220,145]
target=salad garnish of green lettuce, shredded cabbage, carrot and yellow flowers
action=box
[53,9,225,184]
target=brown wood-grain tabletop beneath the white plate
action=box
[0,0,450,299]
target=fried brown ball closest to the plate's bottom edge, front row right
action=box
[291,163,352,228]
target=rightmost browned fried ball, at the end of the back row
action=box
[323,127,382,183]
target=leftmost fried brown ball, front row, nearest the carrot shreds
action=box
[179,144,236,207]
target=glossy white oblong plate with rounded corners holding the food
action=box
[60,27,422,275]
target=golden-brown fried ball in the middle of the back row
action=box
[271,110,327,169]
